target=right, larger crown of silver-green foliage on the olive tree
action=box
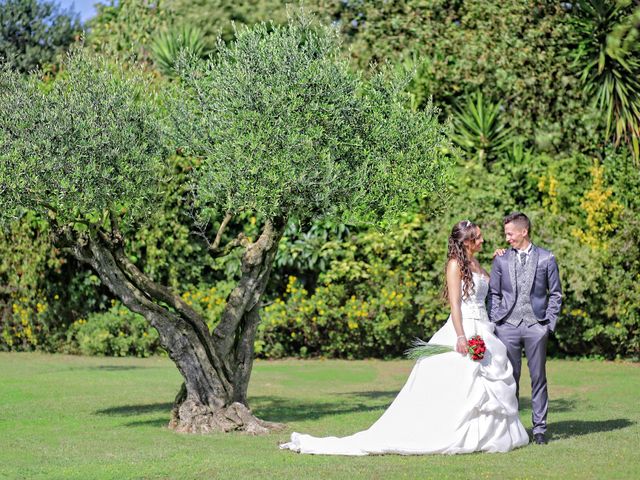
[176,15,448,227]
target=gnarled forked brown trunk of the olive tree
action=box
[62,220,285,434]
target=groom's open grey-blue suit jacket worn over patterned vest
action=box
[489,245,562,332]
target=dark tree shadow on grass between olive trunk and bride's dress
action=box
[250,391,398,423]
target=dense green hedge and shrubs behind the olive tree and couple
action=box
[0,0,640,359]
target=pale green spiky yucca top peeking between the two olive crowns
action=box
[151,25,208,77]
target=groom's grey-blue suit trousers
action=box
[495,322,549,435]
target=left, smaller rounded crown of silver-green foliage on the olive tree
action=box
[0,52,162,229]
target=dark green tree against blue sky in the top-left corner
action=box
[0,0,81,72]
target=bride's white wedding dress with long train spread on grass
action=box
[280,273,529,455]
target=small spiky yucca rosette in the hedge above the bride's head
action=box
[451,92,511,163]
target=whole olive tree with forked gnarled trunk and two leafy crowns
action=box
[0,17,448,433]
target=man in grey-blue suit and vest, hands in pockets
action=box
[489,212,562,445]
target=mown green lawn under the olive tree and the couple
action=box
[0,353,640,480]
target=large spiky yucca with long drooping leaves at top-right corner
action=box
[571,0,640,162]
